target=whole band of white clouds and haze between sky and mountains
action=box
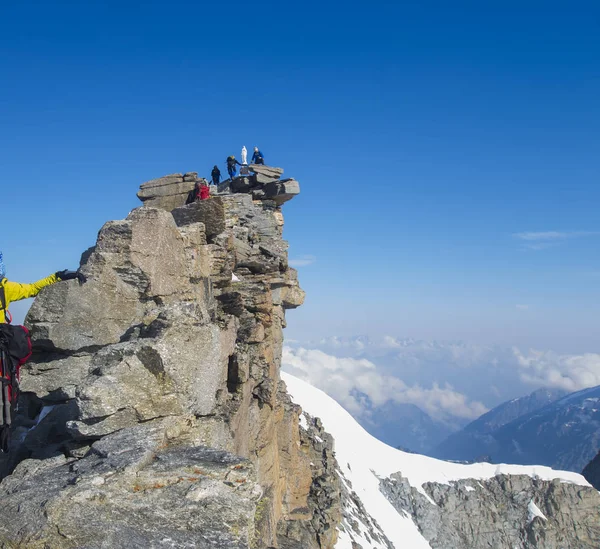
[283,336,600,425]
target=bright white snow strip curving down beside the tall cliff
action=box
[281,372,590,549]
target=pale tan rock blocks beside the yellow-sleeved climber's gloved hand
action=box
[27,208,213,353]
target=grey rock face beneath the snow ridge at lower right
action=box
[381,473,600,549]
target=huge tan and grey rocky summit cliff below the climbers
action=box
[0,169,340,549]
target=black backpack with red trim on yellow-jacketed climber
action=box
[0,286,31,452]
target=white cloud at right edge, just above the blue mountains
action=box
[514,349,600,391]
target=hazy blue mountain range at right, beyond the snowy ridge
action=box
[430,386,600,472]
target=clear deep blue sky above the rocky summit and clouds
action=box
[0,0,600,352]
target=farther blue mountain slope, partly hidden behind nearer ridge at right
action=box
[430,389,566,463]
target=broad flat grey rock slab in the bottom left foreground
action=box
[0,421,261,549]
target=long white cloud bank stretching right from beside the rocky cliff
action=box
[283,347,487,420]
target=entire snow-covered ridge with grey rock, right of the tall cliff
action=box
[282,373,600,549]
